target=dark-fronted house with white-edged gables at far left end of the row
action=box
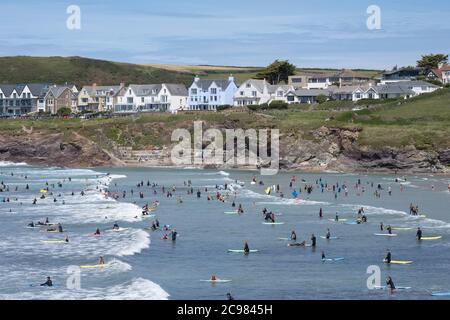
[0,83,49,116]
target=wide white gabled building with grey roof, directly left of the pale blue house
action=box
[113,83,188,113]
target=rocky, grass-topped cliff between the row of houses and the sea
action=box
[0,88,450,173]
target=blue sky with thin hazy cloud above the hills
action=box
[0,0,450,69]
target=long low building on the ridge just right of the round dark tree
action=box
[288,69,370,89]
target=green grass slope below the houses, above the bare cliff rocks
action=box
[0,88,450,150]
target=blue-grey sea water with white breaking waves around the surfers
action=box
[0,163,450,299]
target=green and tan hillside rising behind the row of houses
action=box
[0,56,379,87]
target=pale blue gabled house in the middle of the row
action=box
[188,75,238,111]
